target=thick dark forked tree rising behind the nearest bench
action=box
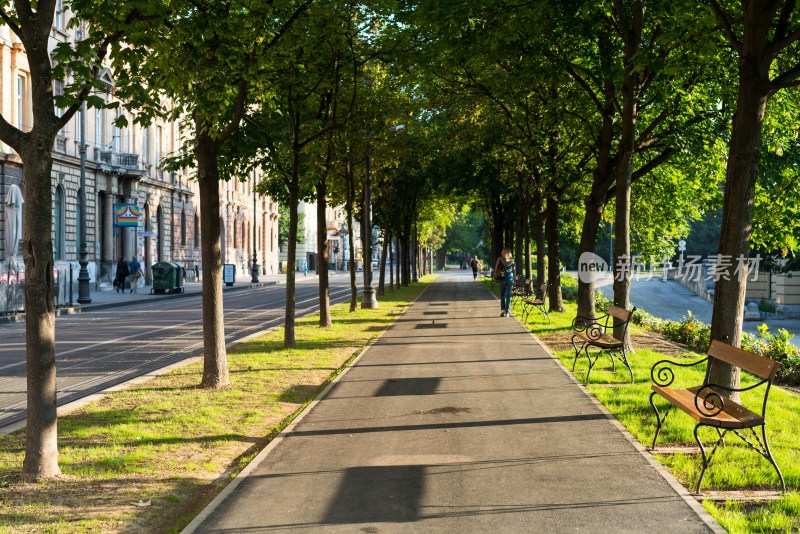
[709,0,800,394]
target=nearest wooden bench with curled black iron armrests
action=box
[650,340,786,493]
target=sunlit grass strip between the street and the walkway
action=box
[0,276,434,533]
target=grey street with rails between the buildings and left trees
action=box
[0,277,350,428]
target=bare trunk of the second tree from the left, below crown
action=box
[195,133,230,388]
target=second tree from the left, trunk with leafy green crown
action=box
[82,0,312,382]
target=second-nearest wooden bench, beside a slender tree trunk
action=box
[572,305,636,384]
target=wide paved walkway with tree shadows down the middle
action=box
[184,272,723,533]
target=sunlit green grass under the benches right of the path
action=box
[495,292,800,532]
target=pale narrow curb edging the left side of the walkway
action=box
[180,280,436,534]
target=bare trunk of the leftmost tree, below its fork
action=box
[20,138,61,482]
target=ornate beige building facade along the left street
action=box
[0,12,279,298]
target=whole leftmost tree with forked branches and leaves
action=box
[0,0,142,481]
